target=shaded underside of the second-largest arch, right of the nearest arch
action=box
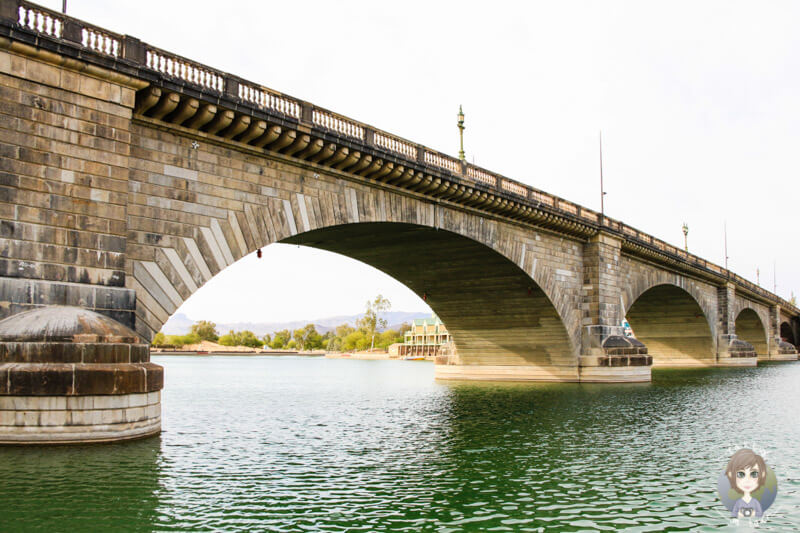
[627,285,716,366]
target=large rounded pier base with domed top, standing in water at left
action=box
[0,307,164,445]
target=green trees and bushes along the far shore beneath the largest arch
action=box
[152,295,411,352]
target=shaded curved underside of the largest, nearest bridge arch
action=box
[280,222,577,367]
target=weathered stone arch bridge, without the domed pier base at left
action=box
[0,0,800,440]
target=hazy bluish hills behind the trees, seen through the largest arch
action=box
[161,311,431,337]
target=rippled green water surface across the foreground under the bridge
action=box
[0,357,800,531]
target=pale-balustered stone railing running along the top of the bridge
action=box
[0,0,790,312]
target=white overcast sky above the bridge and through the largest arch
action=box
[43,0,800,321]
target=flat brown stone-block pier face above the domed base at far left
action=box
[0,45,141,326]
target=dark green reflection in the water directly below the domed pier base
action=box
[0,437,161,531]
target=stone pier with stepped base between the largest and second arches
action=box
[579,232,653,382]
